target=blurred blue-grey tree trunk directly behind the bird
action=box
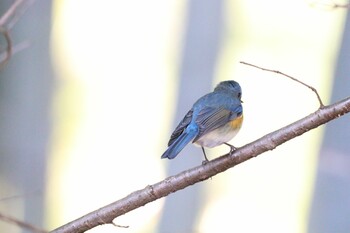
[159,0,223,233]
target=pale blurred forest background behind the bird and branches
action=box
[0,0,350,233]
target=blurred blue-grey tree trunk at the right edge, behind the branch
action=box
[309,9,350,233]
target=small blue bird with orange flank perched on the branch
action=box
[161,80,243,161]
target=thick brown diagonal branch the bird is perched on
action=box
[51,97,350,233]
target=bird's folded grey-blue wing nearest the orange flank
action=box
[193,105,242,142]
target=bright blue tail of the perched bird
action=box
[161,127,198,159]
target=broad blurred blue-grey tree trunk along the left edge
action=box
[0,0,53,232]
